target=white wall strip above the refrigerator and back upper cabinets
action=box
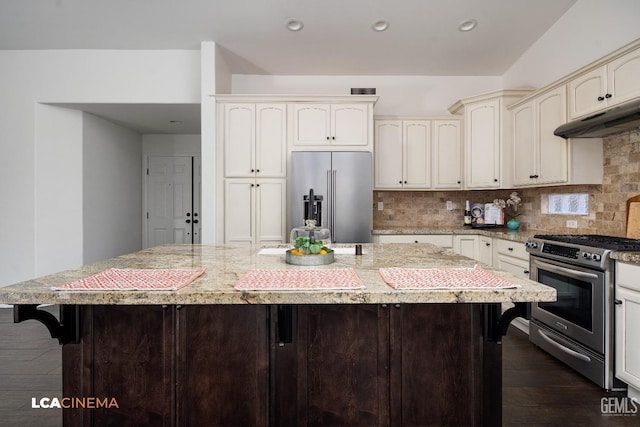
[233,74,502,115]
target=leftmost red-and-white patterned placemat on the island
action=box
[51,268,206,291]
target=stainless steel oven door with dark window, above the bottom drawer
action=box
[530,256,606,354]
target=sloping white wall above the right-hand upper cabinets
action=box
[503,0,640,88]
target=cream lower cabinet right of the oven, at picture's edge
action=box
[615,261,640,396]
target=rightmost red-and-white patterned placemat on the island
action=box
[380,265,519,289]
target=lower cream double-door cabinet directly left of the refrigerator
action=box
[224,178,287,243]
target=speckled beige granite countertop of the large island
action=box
[0,243,556,305]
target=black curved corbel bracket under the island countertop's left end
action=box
[13,304,80,344]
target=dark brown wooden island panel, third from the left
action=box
[272,304,393,427]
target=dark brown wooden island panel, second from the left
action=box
[178,305,269,427]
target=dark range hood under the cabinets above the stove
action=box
[553,99,640,138]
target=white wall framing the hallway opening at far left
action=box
[0,50,200,286]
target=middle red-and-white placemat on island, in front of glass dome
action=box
[235,268,365,291]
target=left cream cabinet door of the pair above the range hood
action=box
[567,66,607,120]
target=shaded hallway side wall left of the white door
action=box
[82,113,142,264]
